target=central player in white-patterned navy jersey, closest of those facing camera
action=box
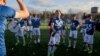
[48,10,63,56]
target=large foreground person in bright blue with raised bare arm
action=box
[0,0,29,56]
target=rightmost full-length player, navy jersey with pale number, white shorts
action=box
[84,15,95,53]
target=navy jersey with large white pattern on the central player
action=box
[51,17,63,31]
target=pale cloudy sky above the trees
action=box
[7,0,100,13]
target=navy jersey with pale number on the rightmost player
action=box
[86,20,95,35]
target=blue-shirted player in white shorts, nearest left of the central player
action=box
[31,15,40,44]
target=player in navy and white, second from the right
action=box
[68,15,79,48]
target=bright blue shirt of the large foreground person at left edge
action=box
[0,5,16,56]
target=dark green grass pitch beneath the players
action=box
[5,27,100,56]
